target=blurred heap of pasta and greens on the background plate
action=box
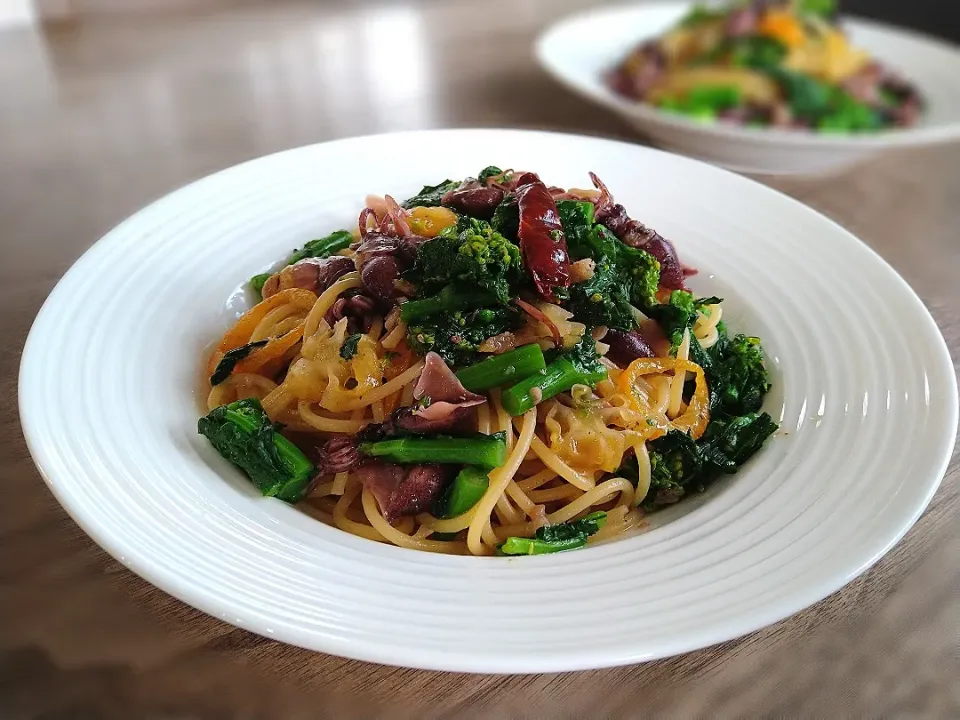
[608,0,923,132]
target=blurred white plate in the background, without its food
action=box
[536,2,960,174]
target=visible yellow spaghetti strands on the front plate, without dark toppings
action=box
[207,255,722,555]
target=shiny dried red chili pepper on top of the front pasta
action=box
[516,173,570,302]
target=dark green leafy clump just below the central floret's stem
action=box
[407,303,518,366]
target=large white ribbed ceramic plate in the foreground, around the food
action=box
[20,130,957,672]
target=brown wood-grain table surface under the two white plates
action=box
[0,0,960,719]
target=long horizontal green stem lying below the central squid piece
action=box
[360,432,507,470]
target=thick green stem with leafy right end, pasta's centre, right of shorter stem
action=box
[500,334,607,417]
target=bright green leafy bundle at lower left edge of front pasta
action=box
[197,398,314,502]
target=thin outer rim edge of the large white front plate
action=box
[18,128,960,674]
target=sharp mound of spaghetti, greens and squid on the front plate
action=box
[199,167,777,555]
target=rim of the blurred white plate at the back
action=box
[533,0,960,149]
